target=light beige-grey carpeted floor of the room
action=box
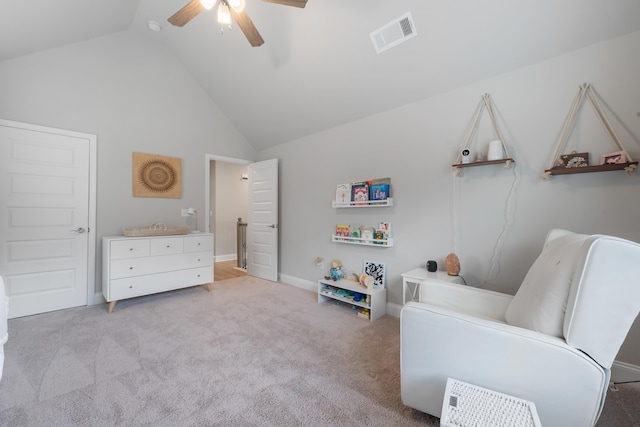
[0,277,640,427]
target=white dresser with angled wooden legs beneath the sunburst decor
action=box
[102,233,213,313]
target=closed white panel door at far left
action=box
[0,121,95,318]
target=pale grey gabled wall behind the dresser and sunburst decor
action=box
[0,31,255,291]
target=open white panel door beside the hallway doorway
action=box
[247,159,278,282]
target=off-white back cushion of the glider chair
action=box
[505,233,589,337]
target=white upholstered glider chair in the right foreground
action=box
[400,230,640,427]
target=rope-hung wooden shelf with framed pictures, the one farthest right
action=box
[542,83,638,180]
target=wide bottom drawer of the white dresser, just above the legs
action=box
[108,267,213,301]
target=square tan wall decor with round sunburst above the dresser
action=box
[132,153,182,199]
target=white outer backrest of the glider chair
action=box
[563,235,640,368]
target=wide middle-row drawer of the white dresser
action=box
[109,251,213,279]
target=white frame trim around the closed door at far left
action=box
[0,119,97,305]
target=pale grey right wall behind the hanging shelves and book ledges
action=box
[260,33,640,365]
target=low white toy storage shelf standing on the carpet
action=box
[318,279,387,321]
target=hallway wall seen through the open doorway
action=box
[212,161,249,261]
